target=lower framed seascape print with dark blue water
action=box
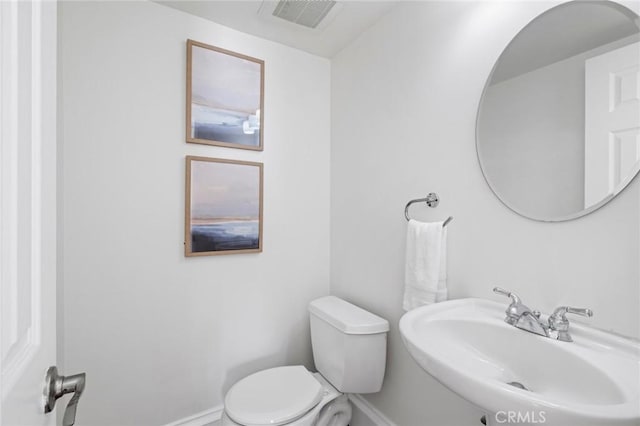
[185,156,262,256]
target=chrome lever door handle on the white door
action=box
[44,367,86,426]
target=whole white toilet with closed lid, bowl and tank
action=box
[222,296,389,426]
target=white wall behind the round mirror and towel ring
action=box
[331,2,640,426]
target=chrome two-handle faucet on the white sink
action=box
[493,287,593,342]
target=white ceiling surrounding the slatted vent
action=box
[155,0,397,58]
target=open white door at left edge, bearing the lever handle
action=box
[0,0,57,426]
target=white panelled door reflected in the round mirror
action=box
[584,43,640,207]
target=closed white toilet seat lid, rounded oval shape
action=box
[224,365,323,426]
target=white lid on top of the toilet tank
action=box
[309,296,389,334]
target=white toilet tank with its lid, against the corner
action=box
[309,296,389,393]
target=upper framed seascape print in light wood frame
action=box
[186,40,264,151]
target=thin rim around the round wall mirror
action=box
[475,0,640,223]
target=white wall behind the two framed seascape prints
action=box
[60,2,330,426]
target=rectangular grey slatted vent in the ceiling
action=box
[258,0,342,30]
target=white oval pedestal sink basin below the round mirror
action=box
[400,299,640,426]
